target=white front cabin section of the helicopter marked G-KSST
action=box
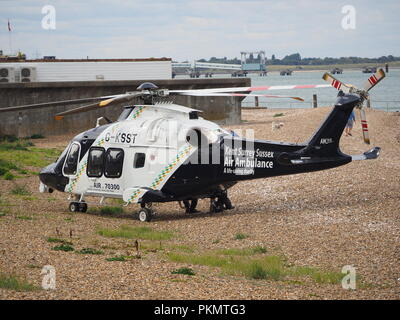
[48,103,225,204]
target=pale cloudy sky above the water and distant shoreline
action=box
[0,0,400,61]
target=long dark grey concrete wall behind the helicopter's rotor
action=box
[0,78,251,137]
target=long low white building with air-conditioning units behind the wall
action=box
[0,56,172,83]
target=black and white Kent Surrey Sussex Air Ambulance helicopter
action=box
[0,69,385,222]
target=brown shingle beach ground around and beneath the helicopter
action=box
[0,108,400,299]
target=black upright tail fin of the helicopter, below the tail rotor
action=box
[304,93,361,157]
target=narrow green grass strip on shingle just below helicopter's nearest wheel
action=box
[97,225,174,240]
